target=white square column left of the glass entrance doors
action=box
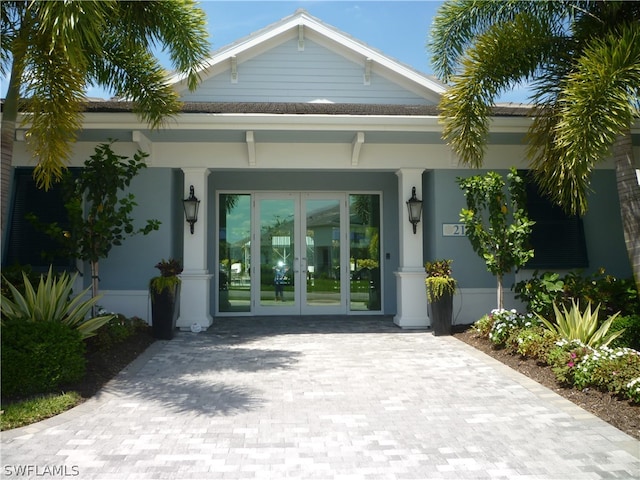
[177,168,213,330]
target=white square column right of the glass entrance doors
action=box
[393,168,430,328]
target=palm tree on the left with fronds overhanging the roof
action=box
[0,0,209,246]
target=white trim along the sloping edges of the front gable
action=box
[169,9,447,103]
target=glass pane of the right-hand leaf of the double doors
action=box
[302,194,345,313]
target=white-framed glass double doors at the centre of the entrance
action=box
[251,192,349,315]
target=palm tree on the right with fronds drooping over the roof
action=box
[429,0,640,291]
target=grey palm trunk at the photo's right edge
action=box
[613,131,640,295]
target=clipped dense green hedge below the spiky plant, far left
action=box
[1,321,85,397]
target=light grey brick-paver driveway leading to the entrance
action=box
[2,317,640,480]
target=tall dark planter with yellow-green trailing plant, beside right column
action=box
[425,260,456,336]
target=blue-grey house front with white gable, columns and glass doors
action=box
[5,11,640,329]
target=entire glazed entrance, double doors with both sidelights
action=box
[218,192,381,315]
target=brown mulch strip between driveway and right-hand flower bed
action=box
[454,329,640,440]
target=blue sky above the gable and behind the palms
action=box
[2,0,526,102]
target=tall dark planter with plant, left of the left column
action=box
[149,259,182,340]
